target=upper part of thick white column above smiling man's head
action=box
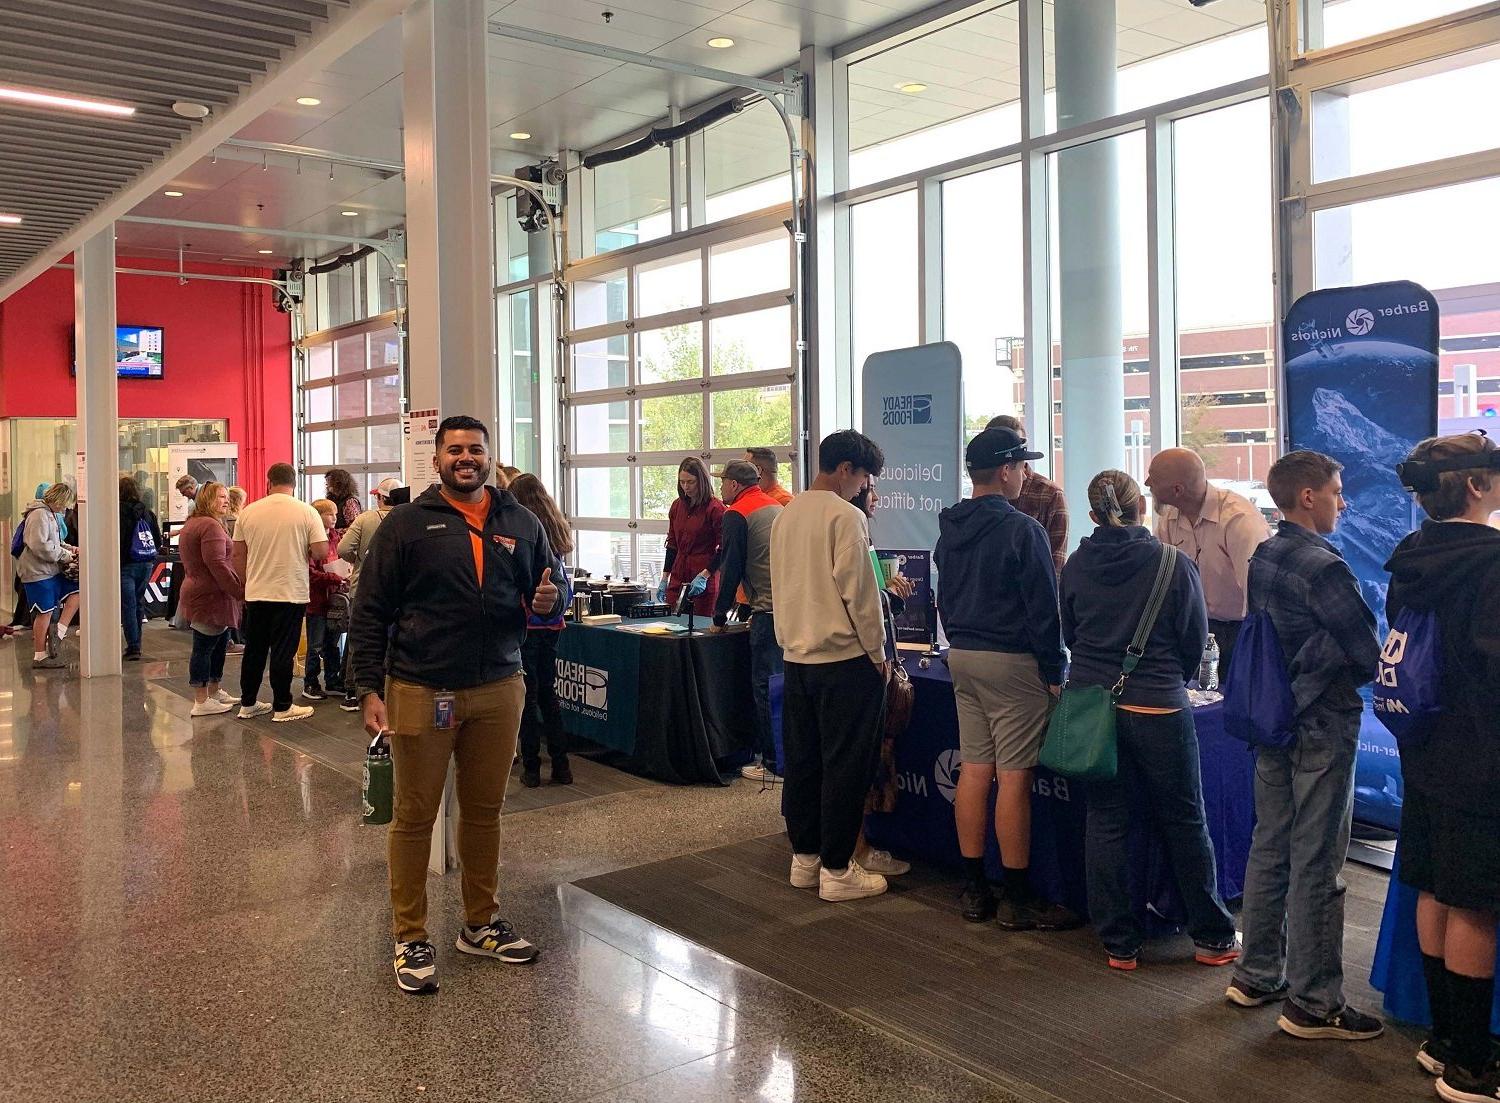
[402,0,498,426]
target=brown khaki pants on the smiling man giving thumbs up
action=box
[386,671,527,942]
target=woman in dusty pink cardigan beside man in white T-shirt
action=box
[177,483,245,716]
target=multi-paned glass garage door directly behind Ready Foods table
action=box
[563,218,800,584]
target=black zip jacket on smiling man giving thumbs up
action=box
[350,486,563,696]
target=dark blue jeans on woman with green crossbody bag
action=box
[1086,708,1235,957]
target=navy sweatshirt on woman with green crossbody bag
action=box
[1062,525,1209,708]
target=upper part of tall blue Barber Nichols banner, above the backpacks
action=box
[1283,281,1437,624]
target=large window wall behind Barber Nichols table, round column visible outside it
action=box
[840,0,1272,522]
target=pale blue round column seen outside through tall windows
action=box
[1056,0,1125,528]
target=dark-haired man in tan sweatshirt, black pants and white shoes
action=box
[771,429,891,900]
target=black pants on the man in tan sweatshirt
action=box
[782,656,885,869]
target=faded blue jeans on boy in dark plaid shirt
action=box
[1235,705,1359,1016]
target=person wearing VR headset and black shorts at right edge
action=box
[1376,434,1500,1103]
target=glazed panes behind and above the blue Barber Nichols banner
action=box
[1278,0,1500,432]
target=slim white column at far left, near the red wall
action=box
[74,225,123,678]
